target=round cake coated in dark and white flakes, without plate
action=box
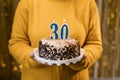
[38,39,80,60]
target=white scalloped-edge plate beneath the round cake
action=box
[34,48,84,66]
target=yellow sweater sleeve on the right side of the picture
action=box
[69,0,102,71]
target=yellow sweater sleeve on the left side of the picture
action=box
[8,0,42,67]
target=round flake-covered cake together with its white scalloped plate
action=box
[30,38,86,66]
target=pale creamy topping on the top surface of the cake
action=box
[41,38,78,48]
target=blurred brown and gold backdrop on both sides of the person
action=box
[0,0,120,80]
